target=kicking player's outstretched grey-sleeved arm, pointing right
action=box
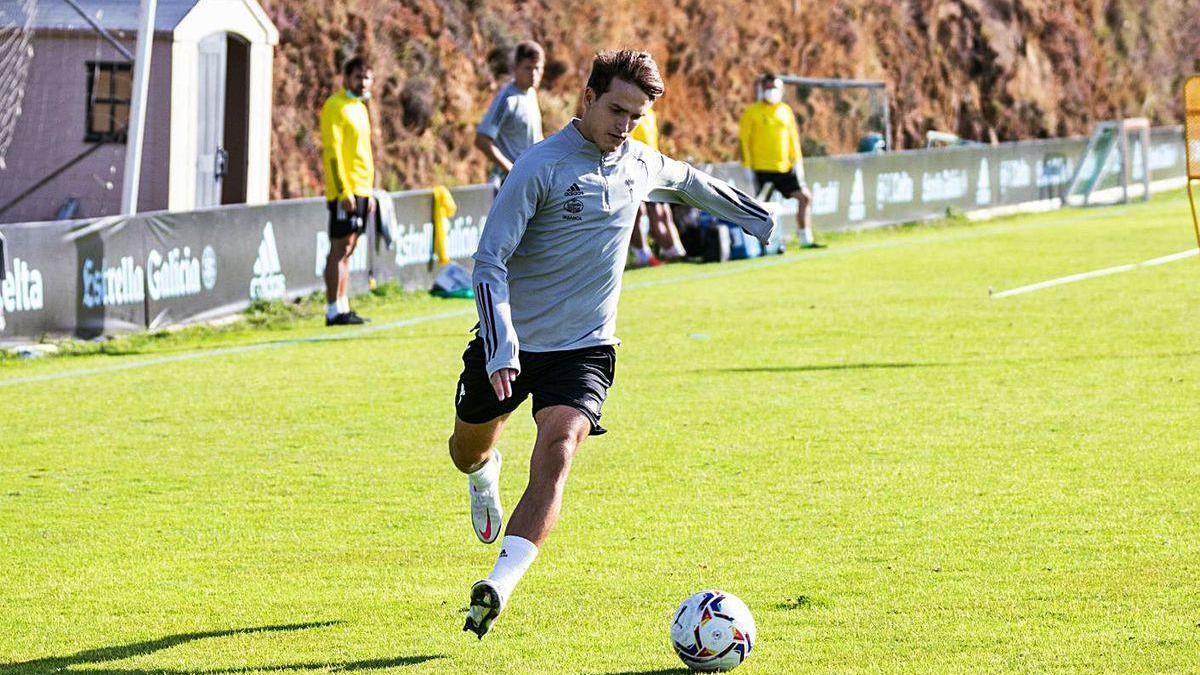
[647,153,775,245]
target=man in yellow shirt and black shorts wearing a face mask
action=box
[738,73,821,249]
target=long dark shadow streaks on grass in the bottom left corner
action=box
[0,621,444,675]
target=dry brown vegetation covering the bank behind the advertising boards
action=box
[263,0,1200,197]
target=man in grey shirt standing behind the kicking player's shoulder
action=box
[475,40,546,187]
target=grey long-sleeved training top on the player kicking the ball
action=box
[472,120,775,375]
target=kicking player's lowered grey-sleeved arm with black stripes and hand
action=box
[472,156,546,389]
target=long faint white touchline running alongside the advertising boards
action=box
[0,209,1166,388]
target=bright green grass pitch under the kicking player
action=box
[0,192,1200,675]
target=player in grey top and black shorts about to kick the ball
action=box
[450,50,774,638]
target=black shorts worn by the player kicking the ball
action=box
[454,338,617,436]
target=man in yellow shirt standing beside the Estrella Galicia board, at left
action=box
[320,56,374,325]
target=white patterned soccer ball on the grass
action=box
[671,591,758,671]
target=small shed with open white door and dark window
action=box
[0,0,278,222]
